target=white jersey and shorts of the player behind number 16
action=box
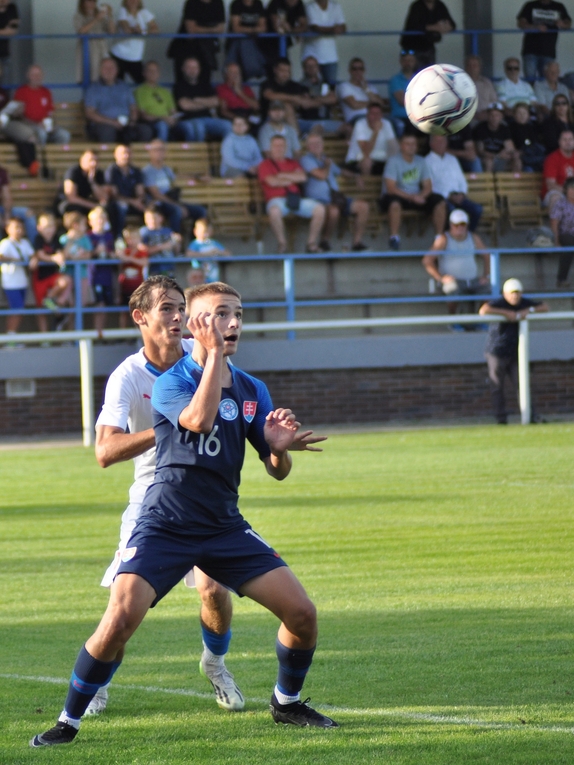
[96,340,193,587]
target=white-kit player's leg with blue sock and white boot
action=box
[193,567,245,712]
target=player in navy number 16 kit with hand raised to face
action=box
[30,282,337,747]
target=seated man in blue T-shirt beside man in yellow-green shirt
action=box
[84,58,153,143]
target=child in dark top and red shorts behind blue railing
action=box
[30,213,73,332]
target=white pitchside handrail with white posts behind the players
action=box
[0,311,574,446]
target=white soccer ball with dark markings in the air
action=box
[405,64,478,135]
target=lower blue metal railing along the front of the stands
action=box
[0,247,574,337]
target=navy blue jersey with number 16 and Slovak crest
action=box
[142,356,273,533]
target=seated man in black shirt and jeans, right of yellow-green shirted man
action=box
[173,58,231,141]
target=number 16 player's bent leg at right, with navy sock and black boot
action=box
[240,566,337,728]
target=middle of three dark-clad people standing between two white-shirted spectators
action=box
[225,0,267,80]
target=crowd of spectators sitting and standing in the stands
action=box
[0,0,574,344]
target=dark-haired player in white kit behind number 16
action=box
[86,276,325,714]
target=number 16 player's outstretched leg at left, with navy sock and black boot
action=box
[30,574,156,747]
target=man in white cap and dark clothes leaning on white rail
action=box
[479,279,548,425]
